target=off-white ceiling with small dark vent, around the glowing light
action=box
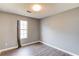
[0,3,79,19]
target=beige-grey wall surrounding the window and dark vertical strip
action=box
[0,12,40,50]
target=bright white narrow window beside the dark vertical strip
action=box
[20,20,28,39]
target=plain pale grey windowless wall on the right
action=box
[41,8,79,54]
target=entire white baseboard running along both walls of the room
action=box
[0,41,79,56]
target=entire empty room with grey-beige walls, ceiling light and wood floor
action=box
[0,3,79,56]
